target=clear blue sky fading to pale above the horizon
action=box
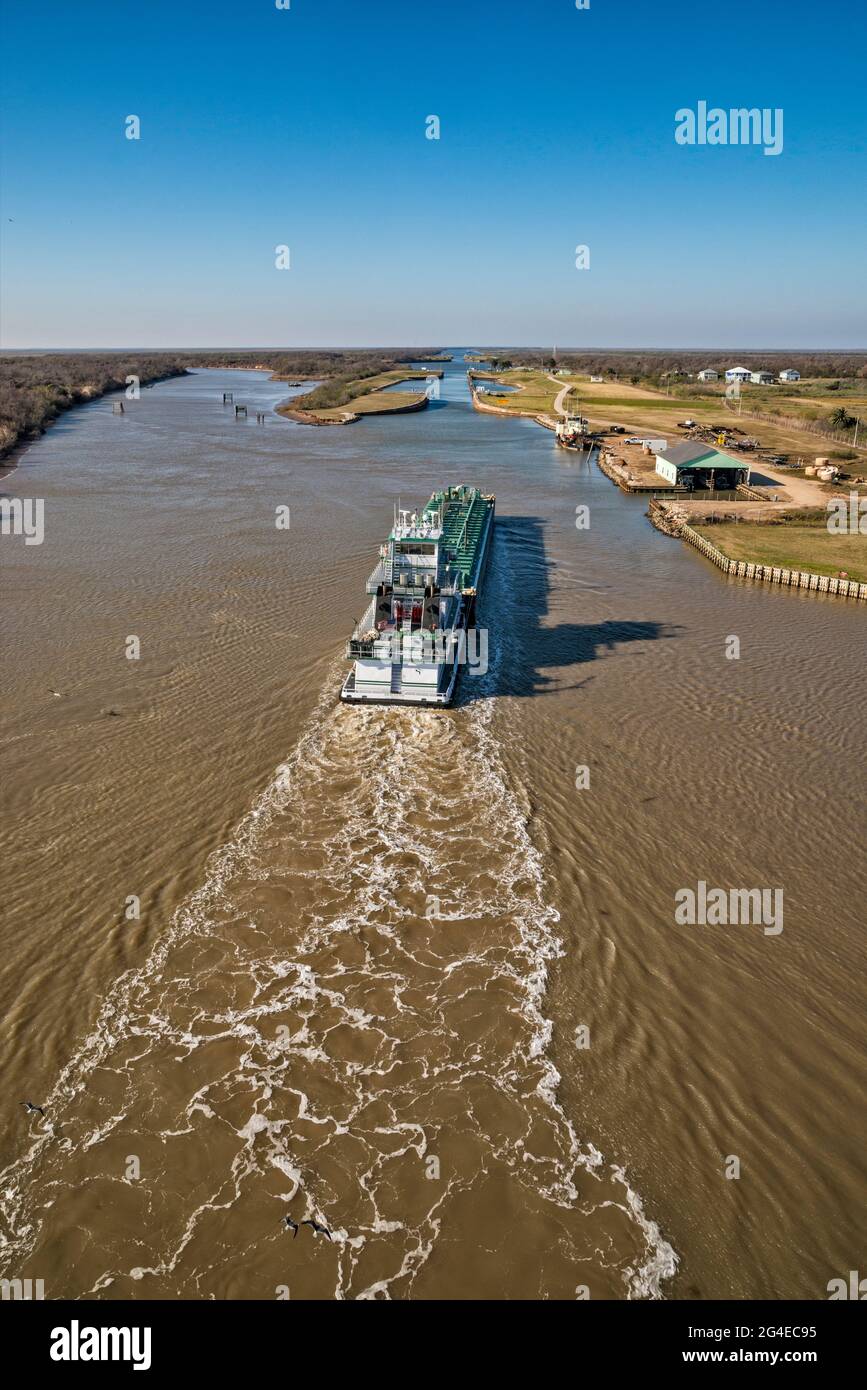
[0,0,867,348]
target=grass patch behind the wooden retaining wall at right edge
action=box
[695,518,867,582]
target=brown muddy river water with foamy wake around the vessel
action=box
[0,359,867,1298]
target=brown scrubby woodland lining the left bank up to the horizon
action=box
[0,348,431,457]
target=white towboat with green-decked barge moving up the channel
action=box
[340,484,495,705]
